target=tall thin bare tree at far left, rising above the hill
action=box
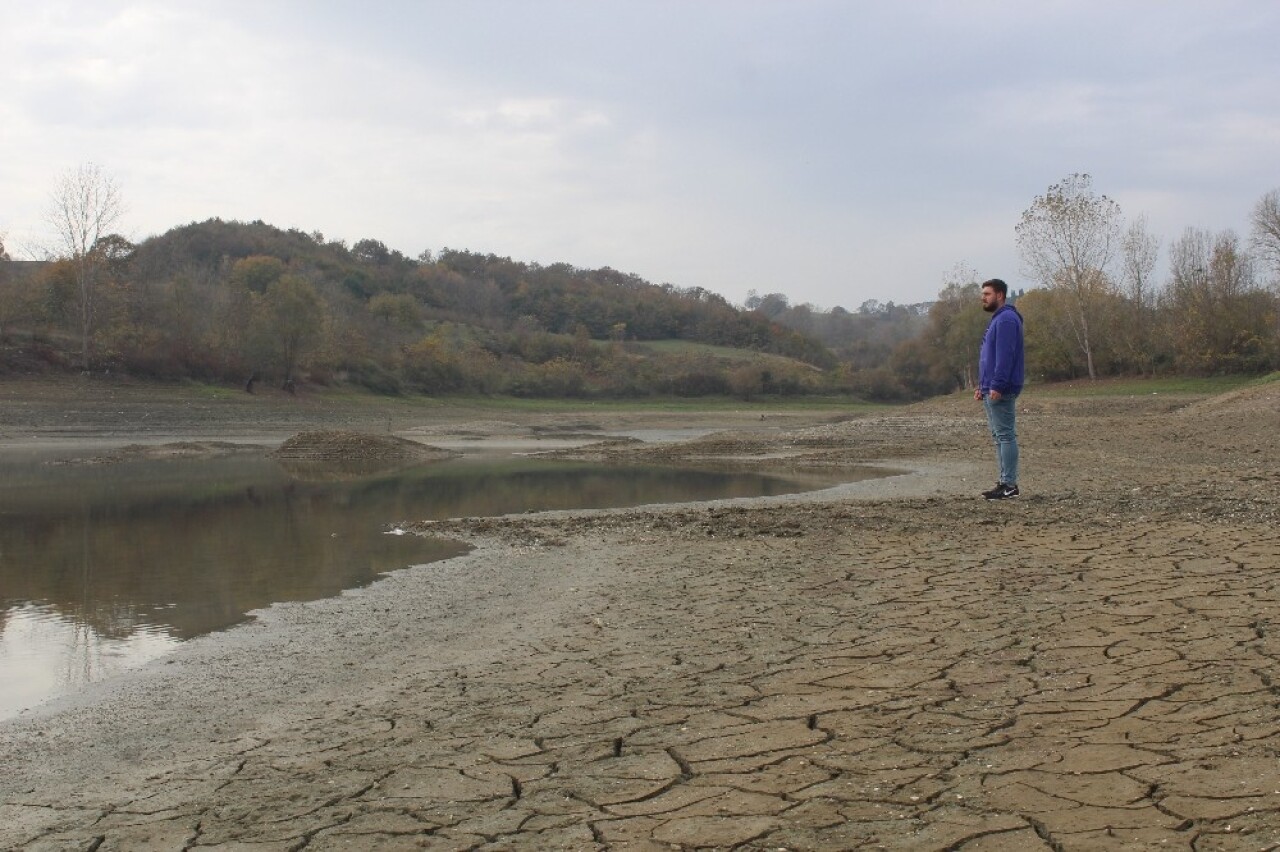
[45,162,124,370]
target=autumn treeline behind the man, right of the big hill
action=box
[748,180,1280,399]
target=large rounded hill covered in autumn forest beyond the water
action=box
[0,219,835,395]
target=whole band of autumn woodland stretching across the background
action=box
[0,173,1280,400]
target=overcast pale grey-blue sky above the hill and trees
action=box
[0,0,1280,308]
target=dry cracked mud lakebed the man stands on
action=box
[0,383,1280,851]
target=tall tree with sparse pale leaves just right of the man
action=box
[1014,174,1121,379]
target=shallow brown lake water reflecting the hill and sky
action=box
[0,453,856,719]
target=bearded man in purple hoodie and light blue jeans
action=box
[973,278,1023,500]
